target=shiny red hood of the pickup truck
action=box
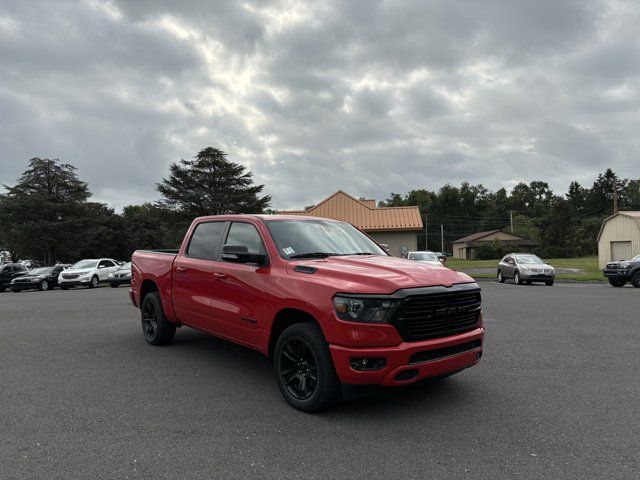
[287,255,474,293]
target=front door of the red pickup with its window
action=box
[211,222,271,346]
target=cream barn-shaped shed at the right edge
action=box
[598,211,640,268]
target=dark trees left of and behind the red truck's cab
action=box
[0,147,271,265]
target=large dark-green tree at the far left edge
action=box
[0,158,92,263]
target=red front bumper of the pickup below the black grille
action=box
[329,327,484,387]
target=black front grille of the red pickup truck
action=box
[392,285,481,341]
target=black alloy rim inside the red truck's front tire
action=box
[279,338,318,400]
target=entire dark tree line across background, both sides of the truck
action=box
[0,147,640,264]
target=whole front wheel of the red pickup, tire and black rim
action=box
[273,322,342,412]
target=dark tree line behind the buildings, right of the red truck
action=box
[379,169,640,258]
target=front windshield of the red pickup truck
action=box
[265,219,387,260]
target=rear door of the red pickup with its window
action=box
[173,221,226,331]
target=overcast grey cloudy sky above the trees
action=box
[0,0,640,208]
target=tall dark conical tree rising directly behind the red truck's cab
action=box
[156,147,271,221]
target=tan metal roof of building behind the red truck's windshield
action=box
[278,190,423,232]
